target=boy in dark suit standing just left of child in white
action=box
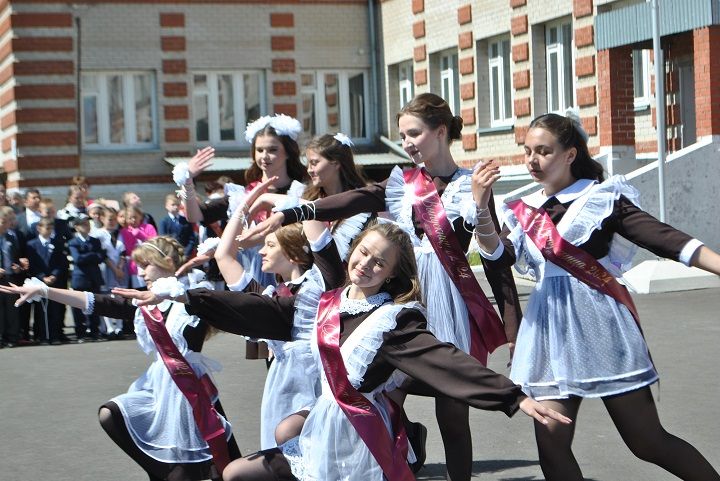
[68,214,106,342]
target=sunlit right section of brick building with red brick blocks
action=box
[381,0,720,172]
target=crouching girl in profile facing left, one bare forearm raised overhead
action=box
[208,177,345,449]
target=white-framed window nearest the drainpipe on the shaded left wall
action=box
[299,71,368,139]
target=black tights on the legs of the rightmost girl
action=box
[535,387,720,481]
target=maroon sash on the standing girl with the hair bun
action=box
[403,167,507,365]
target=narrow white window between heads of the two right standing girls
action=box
[488,38,513,127]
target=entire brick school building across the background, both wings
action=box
[0,0,720,208]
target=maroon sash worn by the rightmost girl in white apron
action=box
[508,199,640,325]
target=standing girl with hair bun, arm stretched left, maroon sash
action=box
[248,93,520,481]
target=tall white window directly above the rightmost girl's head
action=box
[545,21,575,112]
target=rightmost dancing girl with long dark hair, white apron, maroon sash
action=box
[473,110,720,481]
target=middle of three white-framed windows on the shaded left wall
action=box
[192,72,265,145]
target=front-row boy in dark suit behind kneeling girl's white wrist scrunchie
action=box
[27,217,69,345]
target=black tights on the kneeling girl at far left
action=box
[98,401,240,481]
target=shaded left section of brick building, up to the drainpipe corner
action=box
[0,0,376,210]
